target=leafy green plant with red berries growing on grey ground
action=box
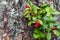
[24,0,60,40]
